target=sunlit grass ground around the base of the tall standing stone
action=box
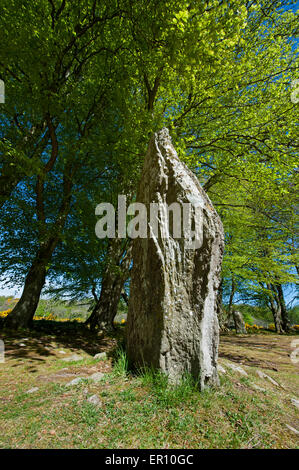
[0,329,298,448]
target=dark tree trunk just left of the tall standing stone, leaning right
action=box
[85,241,131,332]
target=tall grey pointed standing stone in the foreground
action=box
[127,129,224,389]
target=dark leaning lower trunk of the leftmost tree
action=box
[4,240,57,329]
